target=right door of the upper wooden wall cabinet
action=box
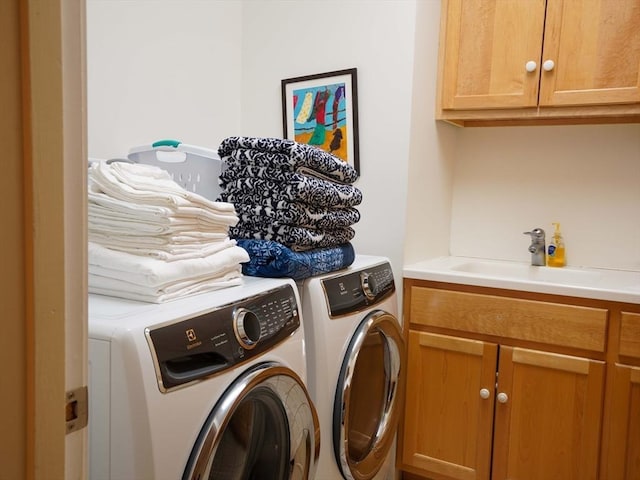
[540,0,640,106]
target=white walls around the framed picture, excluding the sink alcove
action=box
[87,0,420,280]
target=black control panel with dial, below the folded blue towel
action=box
[322,262,396,317]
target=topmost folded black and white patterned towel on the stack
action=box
[218,137,359,184]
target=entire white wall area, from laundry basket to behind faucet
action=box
[87,0,640,277]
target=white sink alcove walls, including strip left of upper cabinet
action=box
[405,1,640,271]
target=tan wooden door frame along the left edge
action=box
[0,0,87,480]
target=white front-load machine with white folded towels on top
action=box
[89,277,320,480]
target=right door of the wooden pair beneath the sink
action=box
[493,347,604,480]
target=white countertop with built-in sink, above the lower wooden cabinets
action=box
[403,257,640,304]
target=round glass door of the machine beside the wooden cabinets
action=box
[333,310,404,480]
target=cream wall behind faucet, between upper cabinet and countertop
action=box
[450,125,640,271]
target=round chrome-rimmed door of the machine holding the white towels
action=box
[183,362,320,480]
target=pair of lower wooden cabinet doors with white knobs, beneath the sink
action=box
[402,330,605,480]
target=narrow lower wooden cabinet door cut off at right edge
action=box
[602,364,640,480]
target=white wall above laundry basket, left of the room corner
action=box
[87,0,242,158]
